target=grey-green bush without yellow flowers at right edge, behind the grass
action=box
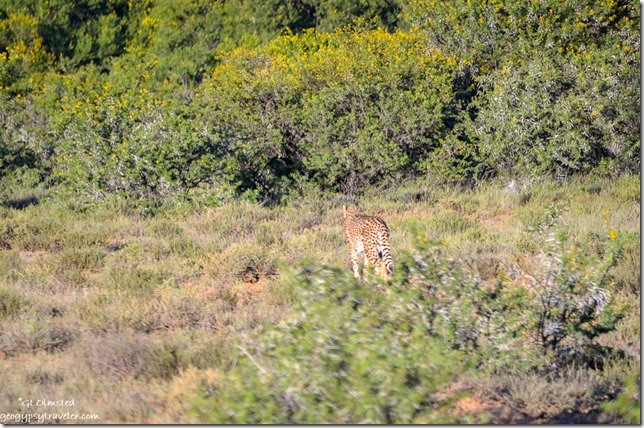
[468,51,640,178]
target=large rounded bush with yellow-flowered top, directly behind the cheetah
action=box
[202,27,451,197]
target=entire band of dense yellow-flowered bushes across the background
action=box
[0,0,640,203]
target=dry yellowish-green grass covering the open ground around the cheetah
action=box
[0,176,640,423]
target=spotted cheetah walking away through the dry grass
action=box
[343,206,394,280]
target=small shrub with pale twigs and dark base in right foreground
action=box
[528,230,622,368]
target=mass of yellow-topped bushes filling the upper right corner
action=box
[403,0,640,179]
